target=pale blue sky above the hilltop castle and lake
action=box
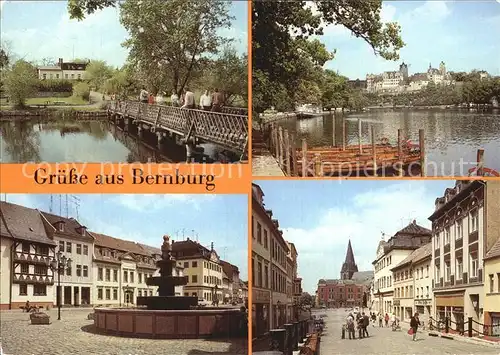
[312,0,500,79]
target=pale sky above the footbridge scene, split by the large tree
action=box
[0,0,248,66]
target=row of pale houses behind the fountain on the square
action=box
[0,202,248,309]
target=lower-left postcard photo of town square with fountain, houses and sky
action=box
[0,194,248,355]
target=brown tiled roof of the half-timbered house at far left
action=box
[0,201,56,245]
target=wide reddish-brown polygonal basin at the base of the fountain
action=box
[94,308,245,339]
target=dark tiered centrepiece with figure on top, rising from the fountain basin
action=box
[137,235,198,310]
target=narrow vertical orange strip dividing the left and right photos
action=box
[247,0,253,354]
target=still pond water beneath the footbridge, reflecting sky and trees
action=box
[0,118,234,163]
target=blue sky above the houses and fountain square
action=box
[2,194,248,280]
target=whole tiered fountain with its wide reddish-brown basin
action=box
[93,236,246,339]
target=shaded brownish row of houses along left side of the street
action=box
[251,184,302,337]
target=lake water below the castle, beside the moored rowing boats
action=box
[278,110,500,176]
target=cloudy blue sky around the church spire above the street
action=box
[255,180,455,294]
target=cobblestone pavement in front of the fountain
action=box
[0,309,248,355]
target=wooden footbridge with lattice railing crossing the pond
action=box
[108,101,248,157]
